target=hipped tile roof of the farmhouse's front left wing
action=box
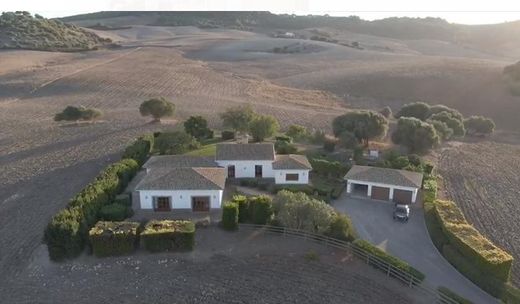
[136,167,227,190]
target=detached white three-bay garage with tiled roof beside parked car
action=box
[344,165,423,204]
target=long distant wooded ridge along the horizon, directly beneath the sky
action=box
[61,12,520,59]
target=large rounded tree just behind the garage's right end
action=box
[392,117,439,153]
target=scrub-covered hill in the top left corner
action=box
[0,12,111,52]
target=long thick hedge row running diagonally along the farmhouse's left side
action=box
[44,159,139,260]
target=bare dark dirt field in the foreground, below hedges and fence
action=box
[0,227,428,303]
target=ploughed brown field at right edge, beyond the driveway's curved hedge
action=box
[439,142,520,285]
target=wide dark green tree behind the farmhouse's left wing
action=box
[154,131,200,154]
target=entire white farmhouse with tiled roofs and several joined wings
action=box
[135,143,312,211]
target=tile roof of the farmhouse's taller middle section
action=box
[215,143,274,160]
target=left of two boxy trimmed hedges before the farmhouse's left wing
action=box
[89,221,140,257]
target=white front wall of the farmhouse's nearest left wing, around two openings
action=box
[139,190,224,209]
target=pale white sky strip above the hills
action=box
[0,0,520,24]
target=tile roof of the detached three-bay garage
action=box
[345,165,423,188]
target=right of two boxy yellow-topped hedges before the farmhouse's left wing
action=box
[141,220,195,252]
